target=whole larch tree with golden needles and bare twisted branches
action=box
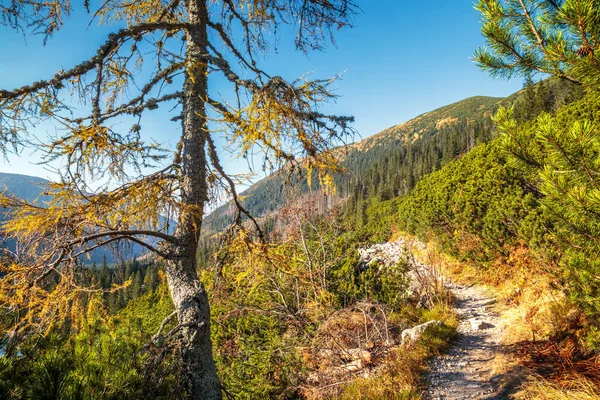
[0,0,356,400]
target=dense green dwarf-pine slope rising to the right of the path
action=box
[398,90,600,322]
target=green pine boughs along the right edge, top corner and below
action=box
[475,0,600,322]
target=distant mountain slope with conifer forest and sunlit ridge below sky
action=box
[203,79,581,236]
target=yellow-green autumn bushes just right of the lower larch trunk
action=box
[202,223,335,321]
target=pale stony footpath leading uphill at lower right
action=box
[424,285,501,400]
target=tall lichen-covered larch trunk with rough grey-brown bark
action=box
[166,0,222,400]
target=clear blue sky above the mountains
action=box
[0,0,522,177]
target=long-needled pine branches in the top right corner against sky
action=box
[475,0,600,88]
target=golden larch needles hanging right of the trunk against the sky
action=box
[213,77,348,194]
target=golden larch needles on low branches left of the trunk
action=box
[0,174,179,290]
